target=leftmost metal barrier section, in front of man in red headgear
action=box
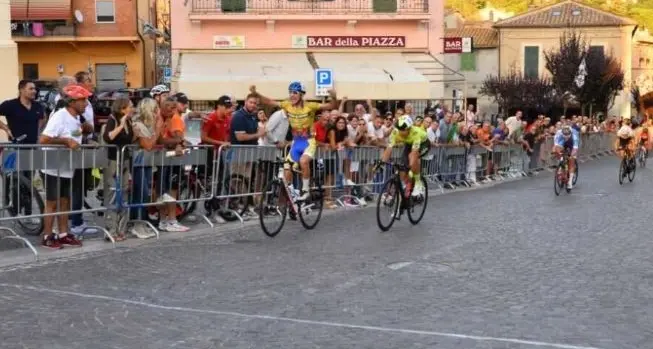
[0,144,115,258]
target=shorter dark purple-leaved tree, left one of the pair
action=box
[479,69,554,113]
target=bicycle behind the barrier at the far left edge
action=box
[0,135,44,236]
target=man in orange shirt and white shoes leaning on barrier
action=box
[158,99,189,232]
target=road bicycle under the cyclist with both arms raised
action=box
[259,158,324,237]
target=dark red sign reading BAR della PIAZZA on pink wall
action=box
[292,35,406,48]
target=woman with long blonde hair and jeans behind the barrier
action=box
[129,98,164,239]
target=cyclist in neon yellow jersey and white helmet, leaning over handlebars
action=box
[381,115,431,197]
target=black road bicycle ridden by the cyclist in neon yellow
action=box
[375,162,429,231]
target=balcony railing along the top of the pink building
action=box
[191,0,429,14]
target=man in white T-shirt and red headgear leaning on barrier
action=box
[39,85,91,249]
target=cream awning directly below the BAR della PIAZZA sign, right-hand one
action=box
[314,52,430,100]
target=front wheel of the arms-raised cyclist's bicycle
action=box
[259,179,289,238]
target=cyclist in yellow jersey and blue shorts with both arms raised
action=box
[249,81,338,201]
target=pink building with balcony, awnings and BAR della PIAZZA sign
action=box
[171,0,444,101]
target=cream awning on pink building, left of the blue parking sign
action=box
[173,53,315,100]
